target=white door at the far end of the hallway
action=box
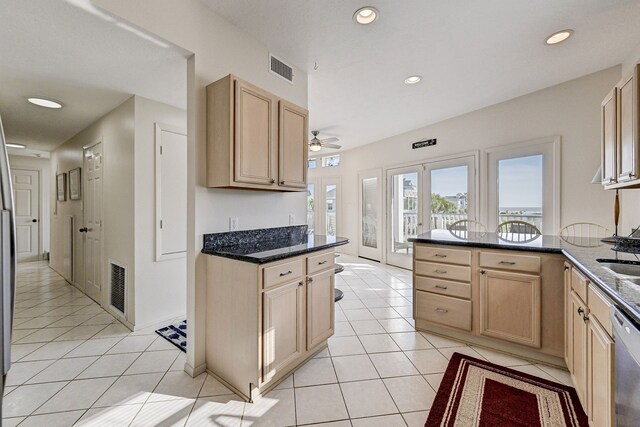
[11,168,40,262]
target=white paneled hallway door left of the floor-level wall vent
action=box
[80,143,103,303]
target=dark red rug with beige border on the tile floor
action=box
[425,353,589,427]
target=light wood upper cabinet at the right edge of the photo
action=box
[601,65,640,189]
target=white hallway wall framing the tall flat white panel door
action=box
[134,97,187,329]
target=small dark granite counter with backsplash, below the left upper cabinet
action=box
[202,225,349,264]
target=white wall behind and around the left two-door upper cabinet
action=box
[94,0,307,373]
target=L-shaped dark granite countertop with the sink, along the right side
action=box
[409,230,640,324]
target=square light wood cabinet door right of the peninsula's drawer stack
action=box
[480,269,541,347]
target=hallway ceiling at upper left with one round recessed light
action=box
[0,0,186,151]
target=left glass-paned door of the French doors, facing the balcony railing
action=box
[387,165,422,269]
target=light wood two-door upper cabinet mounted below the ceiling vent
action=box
[207,74,309,191]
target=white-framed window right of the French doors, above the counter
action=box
[486,137,560,235]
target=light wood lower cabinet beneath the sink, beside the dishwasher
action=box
[565,266,615,427]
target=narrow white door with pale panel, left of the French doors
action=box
[358,169,382,261]
